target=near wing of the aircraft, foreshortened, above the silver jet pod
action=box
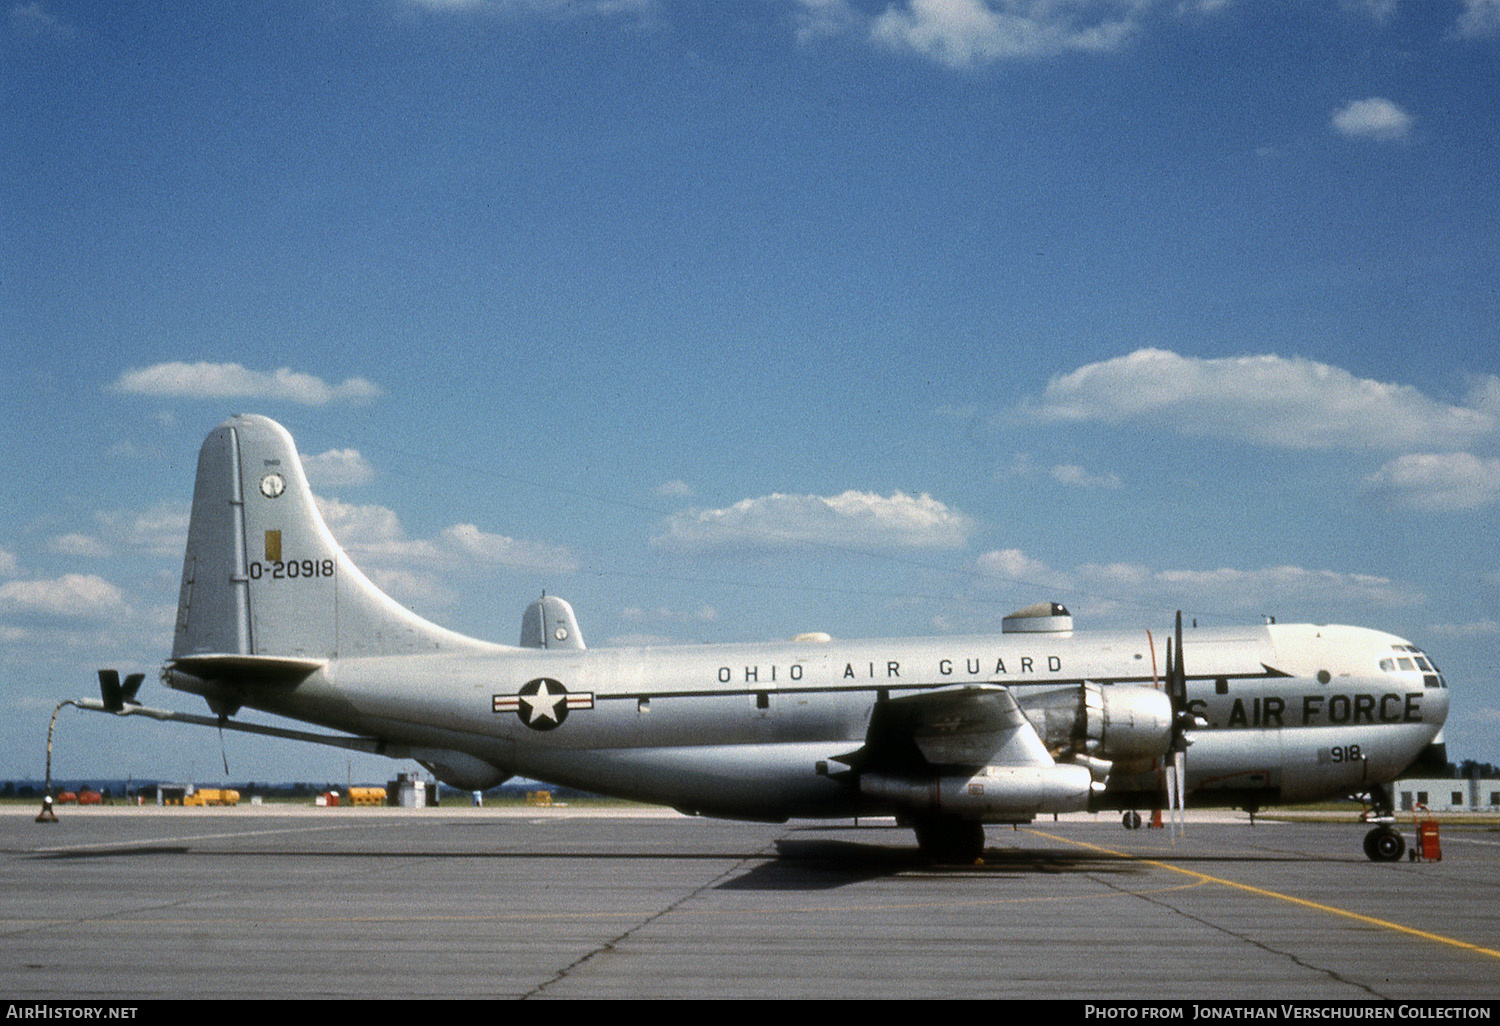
[840,684,1053,773]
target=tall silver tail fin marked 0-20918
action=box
[173,414,495,660]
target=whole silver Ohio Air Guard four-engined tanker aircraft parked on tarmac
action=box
[82,416,1448,860]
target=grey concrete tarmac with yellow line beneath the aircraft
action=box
[0,807,1500,996]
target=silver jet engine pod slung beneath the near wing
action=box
[860,764,1094,822]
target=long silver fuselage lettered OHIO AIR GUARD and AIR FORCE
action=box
[167,624,1448,819]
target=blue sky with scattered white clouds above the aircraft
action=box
[0,0,1500,780]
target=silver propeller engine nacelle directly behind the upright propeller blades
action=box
[1017,681,1172,767]
